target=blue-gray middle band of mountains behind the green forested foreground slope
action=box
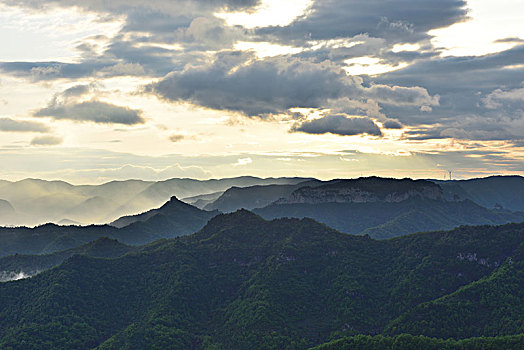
[0,177,524,257]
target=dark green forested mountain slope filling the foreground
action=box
[0,212,524,349]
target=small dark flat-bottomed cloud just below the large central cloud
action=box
[291,114,382,136]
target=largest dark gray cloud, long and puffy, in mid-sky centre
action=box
[146,51,438,117]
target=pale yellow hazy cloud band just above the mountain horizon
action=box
[0,145,524,184]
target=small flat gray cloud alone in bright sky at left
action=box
[34,100,145,125]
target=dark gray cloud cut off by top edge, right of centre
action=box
[258,0,467,43]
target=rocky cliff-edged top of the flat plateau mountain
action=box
[276,177,444,204]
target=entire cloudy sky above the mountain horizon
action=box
[0,0,524,184]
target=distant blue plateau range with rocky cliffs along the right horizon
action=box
[194,176,524,212]
